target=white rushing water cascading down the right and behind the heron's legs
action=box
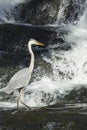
[0,0,87,108]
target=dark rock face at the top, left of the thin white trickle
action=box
[15,0,61,25]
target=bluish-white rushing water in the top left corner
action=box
[0,0,25,23]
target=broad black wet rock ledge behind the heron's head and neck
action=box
[0,24,57,65]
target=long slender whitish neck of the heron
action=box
[28,44,34,72]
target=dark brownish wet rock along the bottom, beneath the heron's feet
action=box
[0,106,87,130]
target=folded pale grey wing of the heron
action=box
[7,68,31,92]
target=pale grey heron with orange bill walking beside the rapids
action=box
[0,39,44,110]
